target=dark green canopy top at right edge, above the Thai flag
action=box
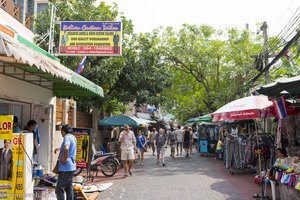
[257,76,300,97]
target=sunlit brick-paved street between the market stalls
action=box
[98,148,259,200]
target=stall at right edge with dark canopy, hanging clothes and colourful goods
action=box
[258,76,300,199]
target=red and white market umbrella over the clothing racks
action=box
[212,95,275,122]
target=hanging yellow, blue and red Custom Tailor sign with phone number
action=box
[59,21,122,56]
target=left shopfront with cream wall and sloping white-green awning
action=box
[0,28,103,174]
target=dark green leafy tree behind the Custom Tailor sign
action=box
[35,0,169,113]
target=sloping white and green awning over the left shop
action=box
[0,33,103,97]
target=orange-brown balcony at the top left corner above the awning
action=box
[0,0,32,29]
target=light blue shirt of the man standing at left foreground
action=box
[58,133,77,172]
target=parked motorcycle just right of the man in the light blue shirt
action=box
[74,153,120,177]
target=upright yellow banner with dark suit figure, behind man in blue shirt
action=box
[73,128,91,168]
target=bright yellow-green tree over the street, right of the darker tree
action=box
[157,24,260,121]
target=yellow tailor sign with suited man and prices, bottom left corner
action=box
[0,115,25,199]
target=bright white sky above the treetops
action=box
[102,0,300,36]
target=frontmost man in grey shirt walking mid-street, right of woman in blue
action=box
[154,128,168,167]
